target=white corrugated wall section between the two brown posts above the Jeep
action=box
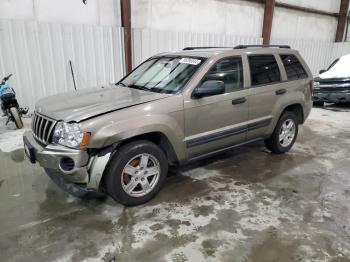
[133,29,262,66]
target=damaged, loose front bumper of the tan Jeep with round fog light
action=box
[23,131,111,191]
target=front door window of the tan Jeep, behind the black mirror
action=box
[205,57,243,93]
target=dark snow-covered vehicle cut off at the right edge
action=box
[313,54,350,106]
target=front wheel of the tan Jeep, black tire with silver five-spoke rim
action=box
[104,140,168,206]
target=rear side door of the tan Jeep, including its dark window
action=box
[247,54,286,140]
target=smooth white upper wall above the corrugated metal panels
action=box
[0,0,340,41]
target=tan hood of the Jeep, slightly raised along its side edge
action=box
[35,85,170,122]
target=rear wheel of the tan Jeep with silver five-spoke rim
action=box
[265,111,298,154]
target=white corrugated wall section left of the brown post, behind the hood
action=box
[0,20,124,108]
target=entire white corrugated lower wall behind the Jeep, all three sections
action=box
[0,20,350,111]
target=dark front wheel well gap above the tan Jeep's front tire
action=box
[118,132,178,165]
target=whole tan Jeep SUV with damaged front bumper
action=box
[24,46,313,205]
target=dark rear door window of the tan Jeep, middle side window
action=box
[248,55,281,86]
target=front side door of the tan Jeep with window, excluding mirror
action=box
[185,56,248,158]
